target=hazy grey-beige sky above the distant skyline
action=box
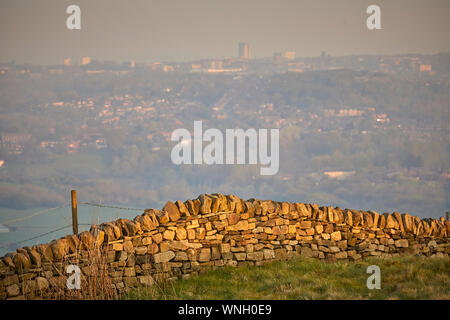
[0,0,450,64]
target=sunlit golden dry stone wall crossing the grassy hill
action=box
[0,194,450,299]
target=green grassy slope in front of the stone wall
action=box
[123,256,450,300]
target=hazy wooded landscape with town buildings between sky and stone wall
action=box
[0,42,450,216]
